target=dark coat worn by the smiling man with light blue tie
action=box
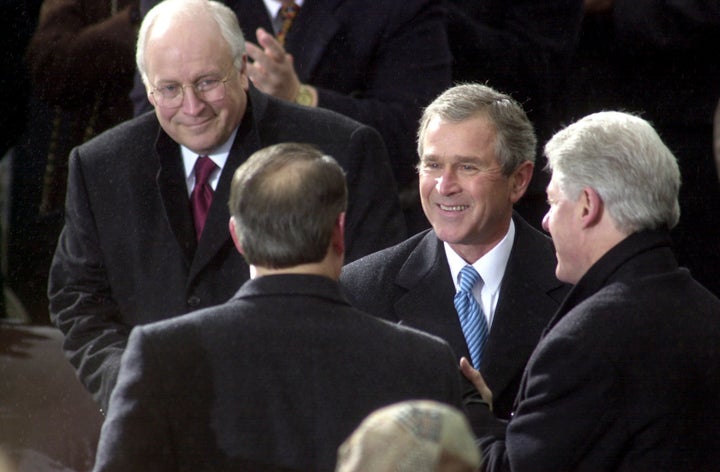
[341,214,568,424]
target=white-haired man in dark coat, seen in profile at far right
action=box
[462,112,720,472]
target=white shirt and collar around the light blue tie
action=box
[443,219,515,325]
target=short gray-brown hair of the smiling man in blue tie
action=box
[417,84,537,175]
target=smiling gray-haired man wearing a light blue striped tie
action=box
[341,84,568,431]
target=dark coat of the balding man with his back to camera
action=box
[95,275,462,472]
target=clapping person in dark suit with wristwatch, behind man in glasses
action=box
[132,0,452,234]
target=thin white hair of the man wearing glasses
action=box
[135,0,245,86]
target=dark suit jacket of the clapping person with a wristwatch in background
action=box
[133,0,451,185]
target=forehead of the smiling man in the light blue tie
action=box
[421,116,497,160]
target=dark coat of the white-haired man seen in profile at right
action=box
[481,231,720,471]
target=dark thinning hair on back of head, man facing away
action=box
[228,143,347,269]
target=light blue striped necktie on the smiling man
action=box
[455,265,488,370]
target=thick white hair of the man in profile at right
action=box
[545,111,680,234]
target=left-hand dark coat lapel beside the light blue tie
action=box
[395,230,469,358]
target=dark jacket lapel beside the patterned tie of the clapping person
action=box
[284,0,343,82]
